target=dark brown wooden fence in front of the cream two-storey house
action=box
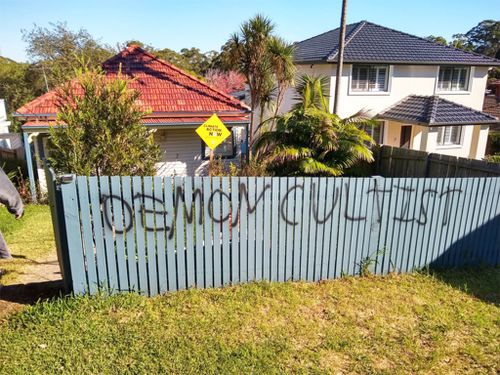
[375,146,500,177]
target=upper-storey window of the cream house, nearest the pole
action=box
[351,65,389,92]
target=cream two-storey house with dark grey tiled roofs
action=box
[281,21,500,159]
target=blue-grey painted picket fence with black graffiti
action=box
[49,171,500,295]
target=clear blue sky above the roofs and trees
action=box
[0,0,500,61]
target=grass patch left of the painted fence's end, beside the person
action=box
[0,205,55,284]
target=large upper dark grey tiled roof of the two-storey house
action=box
[295,21,500,66]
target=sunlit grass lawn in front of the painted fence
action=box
[0,268,500,374]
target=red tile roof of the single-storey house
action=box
[15,45,249,125]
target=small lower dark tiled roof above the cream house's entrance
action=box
[376,95,499,126]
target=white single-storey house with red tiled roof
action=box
[14,45,250,200]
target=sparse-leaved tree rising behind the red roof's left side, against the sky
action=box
[22,22,113,88]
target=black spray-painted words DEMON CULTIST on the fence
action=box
[101,180,462,238]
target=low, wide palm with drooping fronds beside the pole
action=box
[255,76,374,176]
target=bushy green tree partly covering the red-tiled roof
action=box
[49,71,160,176]
